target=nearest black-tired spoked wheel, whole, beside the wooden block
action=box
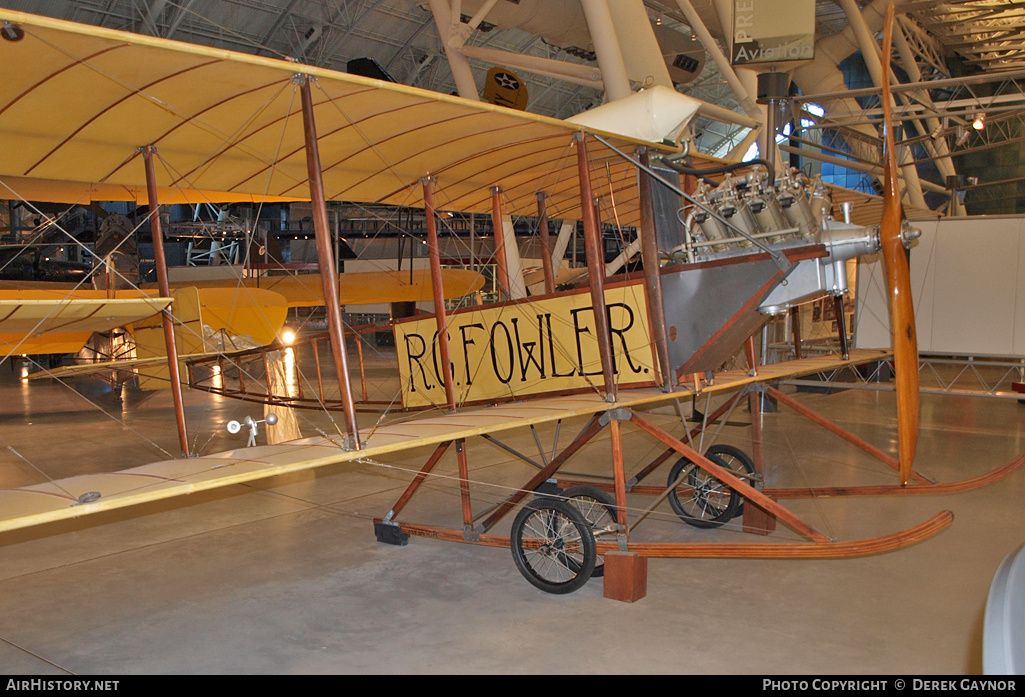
[509,497,597,593]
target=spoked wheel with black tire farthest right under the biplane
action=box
[666,453,741,528]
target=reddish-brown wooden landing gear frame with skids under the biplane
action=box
[364,371,1025,600]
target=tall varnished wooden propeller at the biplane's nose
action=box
[879,3,918,484]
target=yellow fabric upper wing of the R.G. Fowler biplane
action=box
[0,10,688,224]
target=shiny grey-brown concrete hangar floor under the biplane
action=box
[0,348,1025,675]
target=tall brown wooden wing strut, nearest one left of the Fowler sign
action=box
[299,76,361,450]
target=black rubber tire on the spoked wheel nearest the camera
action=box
[509,496,597,595]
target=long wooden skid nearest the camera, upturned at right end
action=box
[383,510,954,559]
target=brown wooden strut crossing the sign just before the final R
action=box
[574,132,616,402]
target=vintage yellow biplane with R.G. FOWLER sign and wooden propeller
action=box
[0,6,1022,600]
